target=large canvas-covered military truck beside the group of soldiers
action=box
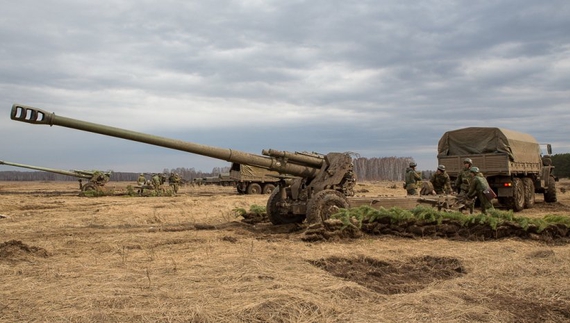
[437,127,556,211]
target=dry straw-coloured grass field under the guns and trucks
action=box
[0,181,570,323]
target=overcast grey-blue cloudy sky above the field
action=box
[0,0,570,176]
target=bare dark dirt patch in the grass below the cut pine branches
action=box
[310,256,465,295]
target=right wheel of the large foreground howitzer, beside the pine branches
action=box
[307,190,349,224]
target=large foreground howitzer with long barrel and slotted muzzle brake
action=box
[10,104,355,224]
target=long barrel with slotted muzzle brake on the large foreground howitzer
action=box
[10,104,319,178]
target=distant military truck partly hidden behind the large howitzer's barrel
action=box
[230,163,280,194]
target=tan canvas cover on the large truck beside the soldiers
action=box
[437,127,542,163]
